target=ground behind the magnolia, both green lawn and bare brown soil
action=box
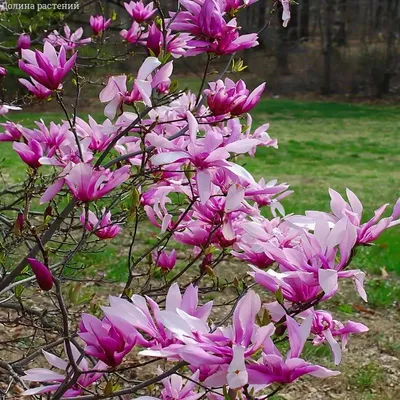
[0,99,400,400]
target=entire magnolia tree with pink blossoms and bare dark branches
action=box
[0,0,400,400]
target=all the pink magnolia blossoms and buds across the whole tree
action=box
[0,0,400,400]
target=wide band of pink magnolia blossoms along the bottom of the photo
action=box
[23,284,368,400]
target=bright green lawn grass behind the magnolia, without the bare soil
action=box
[0,99,400,290]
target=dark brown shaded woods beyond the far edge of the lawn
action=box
[0,0,400,98]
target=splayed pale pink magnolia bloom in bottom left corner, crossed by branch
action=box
[21,343,107,398]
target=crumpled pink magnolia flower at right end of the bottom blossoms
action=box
[303,310,368,365]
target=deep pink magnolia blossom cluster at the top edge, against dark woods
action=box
[121,0,258,58]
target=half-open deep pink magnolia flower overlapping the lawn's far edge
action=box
[204,78,265,115]
